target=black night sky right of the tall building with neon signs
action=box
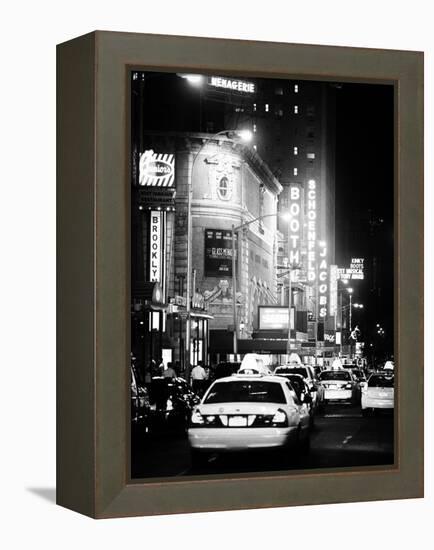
[336,84,394,349]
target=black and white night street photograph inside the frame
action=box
[129,70,398,479]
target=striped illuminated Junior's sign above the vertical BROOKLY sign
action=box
[139,149,175,187]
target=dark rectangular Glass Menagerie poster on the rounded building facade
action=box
[205,229,236,277]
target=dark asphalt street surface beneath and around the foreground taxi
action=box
[131,405,393,478]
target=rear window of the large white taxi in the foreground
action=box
[205,380,286,403]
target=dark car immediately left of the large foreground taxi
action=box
[150,376,200,432]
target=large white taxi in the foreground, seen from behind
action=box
[188,374,310,465]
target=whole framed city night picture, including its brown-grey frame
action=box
[57,31,423,518]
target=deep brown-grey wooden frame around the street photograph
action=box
[57,31,423,518]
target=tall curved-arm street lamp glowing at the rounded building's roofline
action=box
[184,130,252,379]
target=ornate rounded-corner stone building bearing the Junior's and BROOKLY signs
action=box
[132,132,282,378]
